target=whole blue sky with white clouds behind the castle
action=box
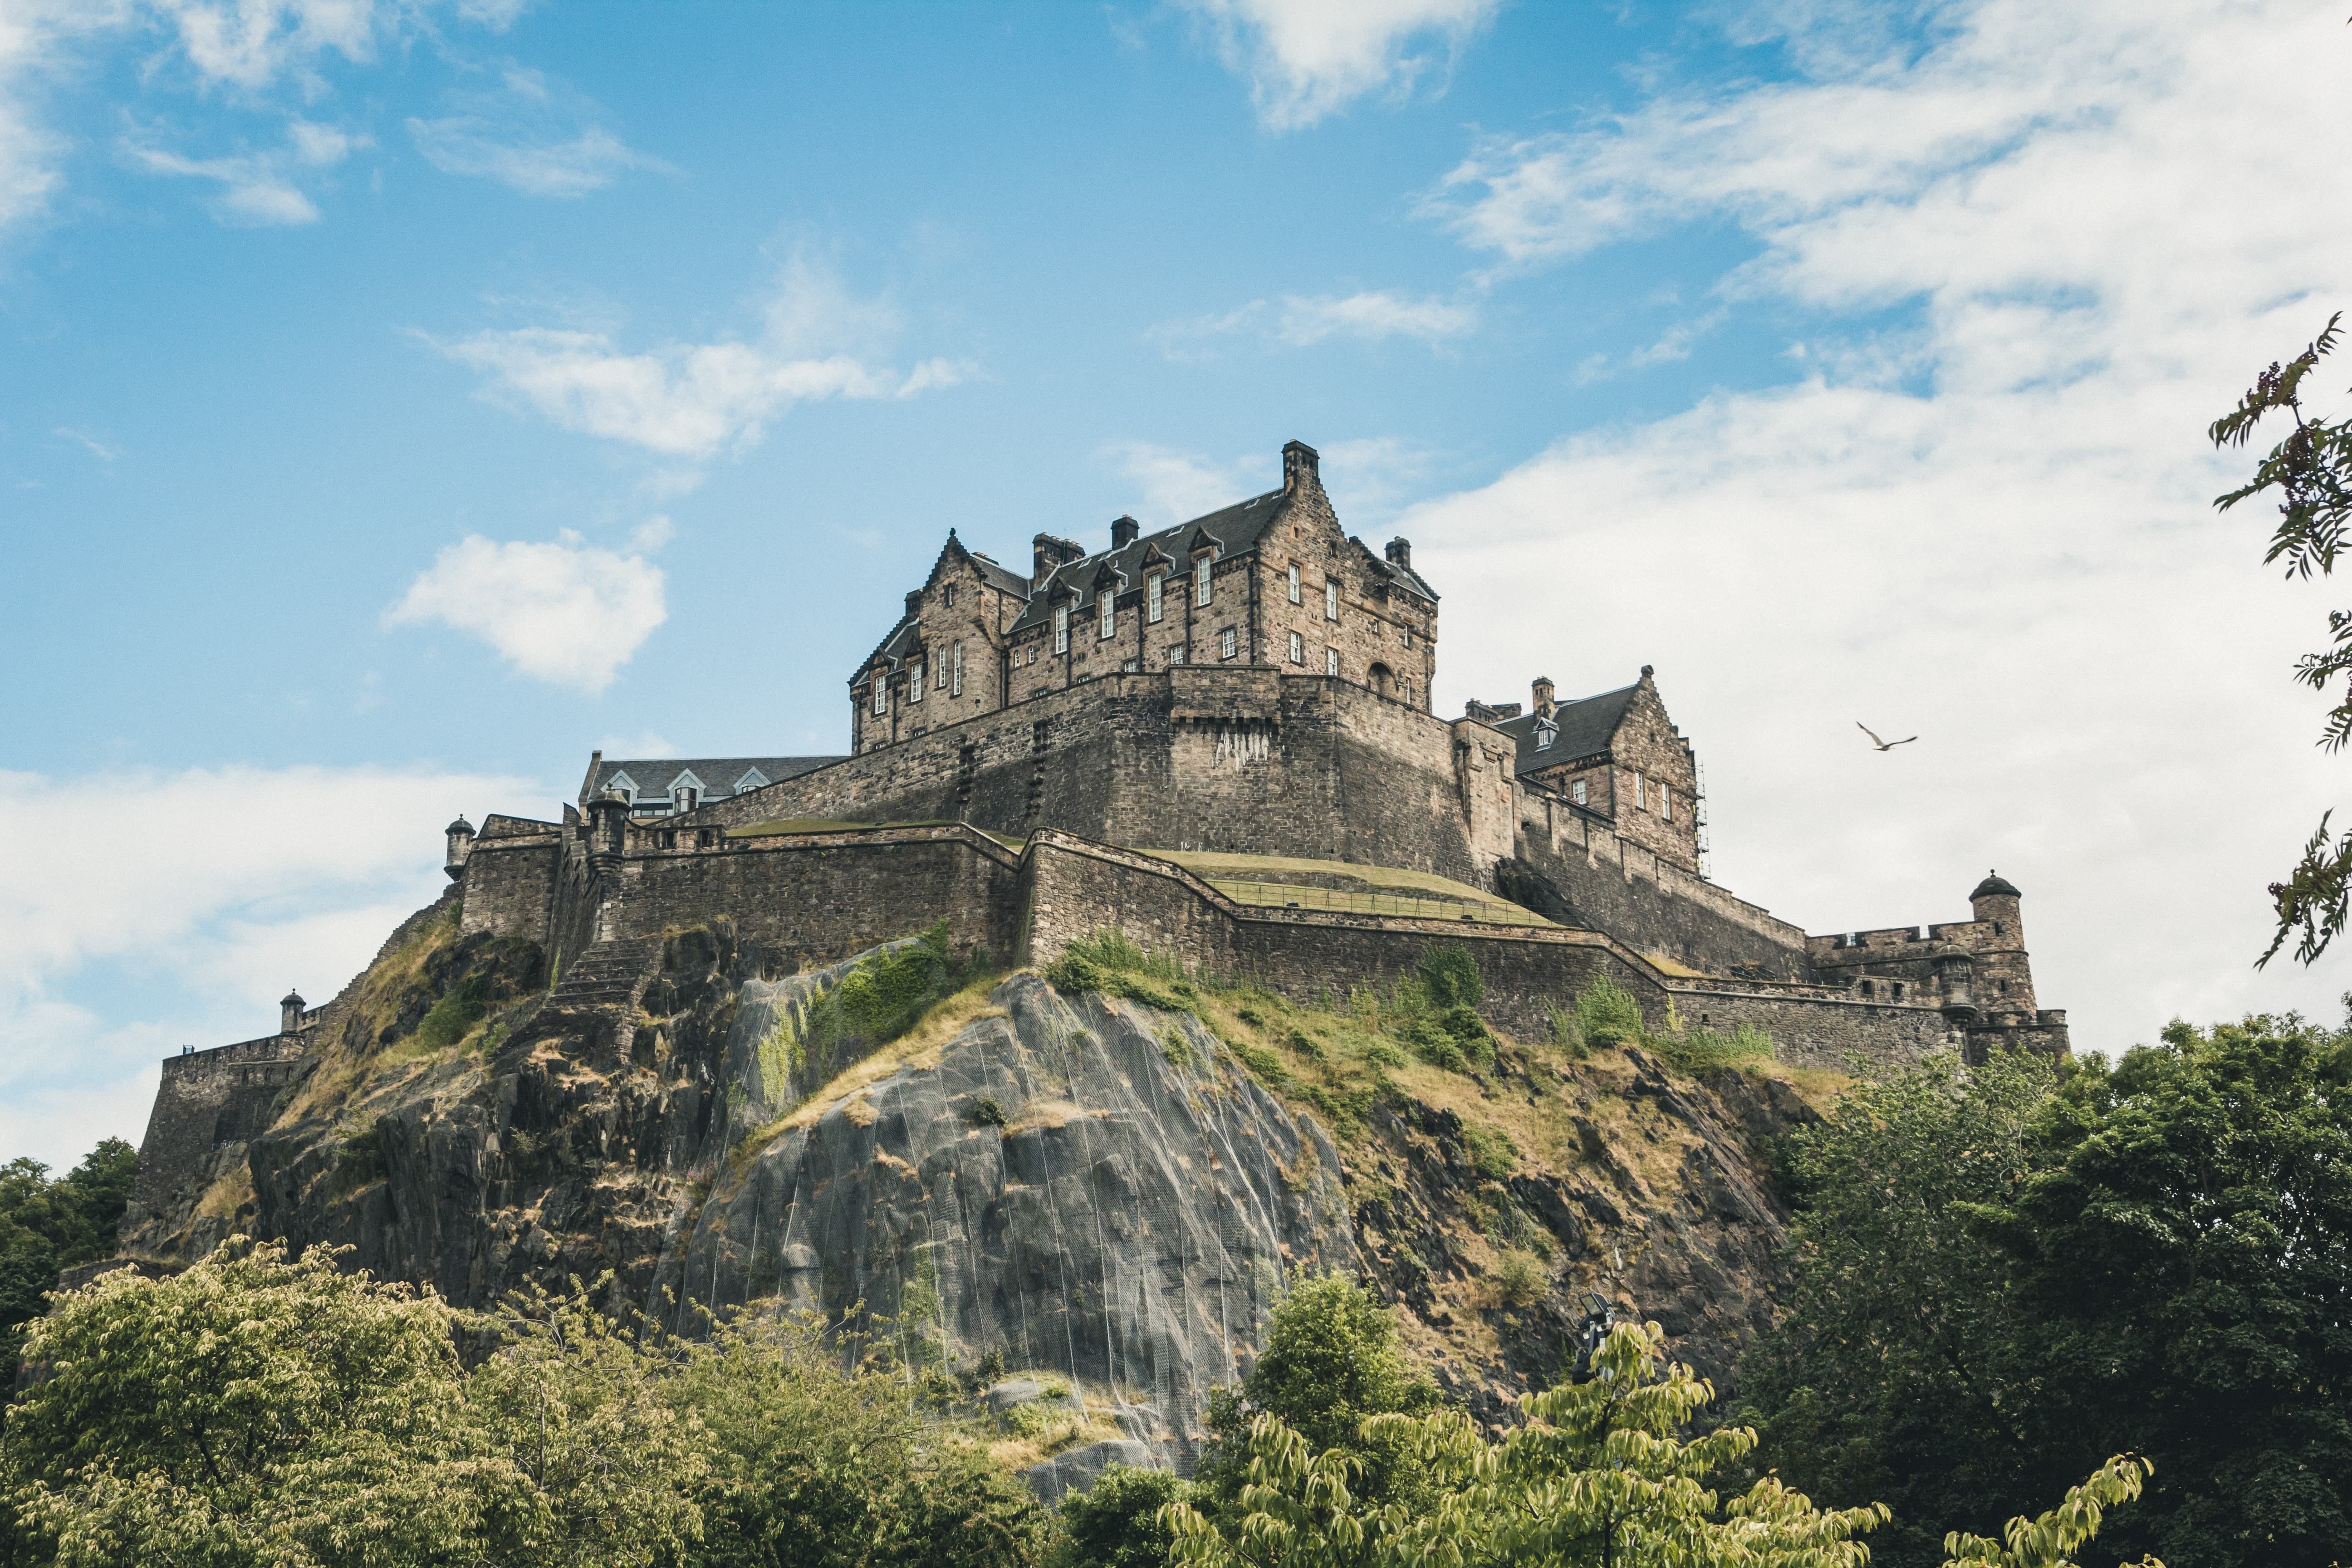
[0,0,2352,1159]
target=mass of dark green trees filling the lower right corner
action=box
[1740,1018,2352,1568]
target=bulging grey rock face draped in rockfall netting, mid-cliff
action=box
[663,966,1355,1469]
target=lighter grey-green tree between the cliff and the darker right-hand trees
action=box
[1738,1053,2060,1568]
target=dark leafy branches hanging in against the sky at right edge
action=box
[2209,313,2352,964]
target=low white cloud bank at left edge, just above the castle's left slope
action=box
[0,769,539,1166]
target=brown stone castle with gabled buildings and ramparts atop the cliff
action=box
[134,442,2068,1241]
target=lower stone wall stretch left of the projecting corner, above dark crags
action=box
[604,825,1021,964]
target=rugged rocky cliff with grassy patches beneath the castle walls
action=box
[125,910,1811,1490]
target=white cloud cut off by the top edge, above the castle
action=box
[1183,0,1500,132]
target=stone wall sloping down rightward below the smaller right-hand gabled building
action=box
[1496,785,1811,980]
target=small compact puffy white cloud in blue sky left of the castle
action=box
[383,531,670,696]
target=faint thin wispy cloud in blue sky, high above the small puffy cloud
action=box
[407,66,668,197]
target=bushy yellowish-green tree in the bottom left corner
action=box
[5,1239,520,1568]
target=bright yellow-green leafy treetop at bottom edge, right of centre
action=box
[1166,1323,1884,1568]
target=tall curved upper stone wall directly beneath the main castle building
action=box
[672,665,1510,886]
